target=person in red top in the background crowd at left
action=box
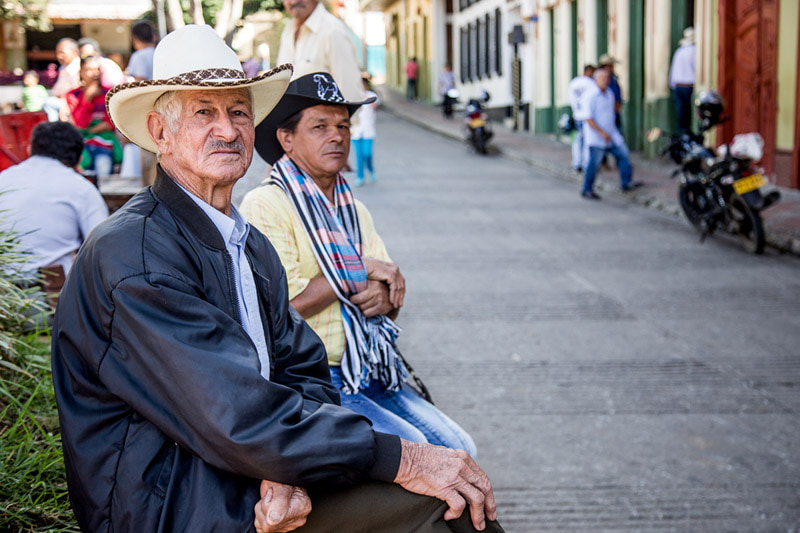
[67,55,122,178]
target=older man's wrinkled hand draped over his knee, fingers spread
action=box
[394,440,497,531]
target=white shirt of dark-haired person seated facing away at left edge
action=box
[0,155,108,274]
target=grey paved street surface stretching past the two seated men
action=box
[234,112,800,533]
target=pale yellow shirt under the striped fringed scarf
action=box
[239,185,391,366]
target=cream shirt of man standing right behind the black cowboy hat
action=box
[278,2,364,102]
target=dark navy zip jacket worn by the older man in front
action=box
[52,170,400,533]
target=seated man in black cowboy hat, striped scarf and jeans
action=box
[241,72,476,462]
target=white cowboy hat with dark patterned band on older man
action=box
[106,24,292,152]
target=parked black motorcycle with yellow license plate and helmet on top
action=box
[648,91,780,254]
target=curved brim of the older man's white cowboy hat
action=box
[106,63,292,153]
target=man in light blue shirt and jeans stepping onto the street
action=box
[581,69,642,200]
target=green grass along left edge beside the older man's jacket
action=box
[0,220,78,531]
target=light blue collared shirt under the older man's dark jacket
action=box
[178,184,269,380]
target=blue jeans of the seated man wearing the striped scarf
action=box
[331,366,478,457]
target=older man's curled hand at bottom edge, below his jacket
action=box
[255,480,311,533]
